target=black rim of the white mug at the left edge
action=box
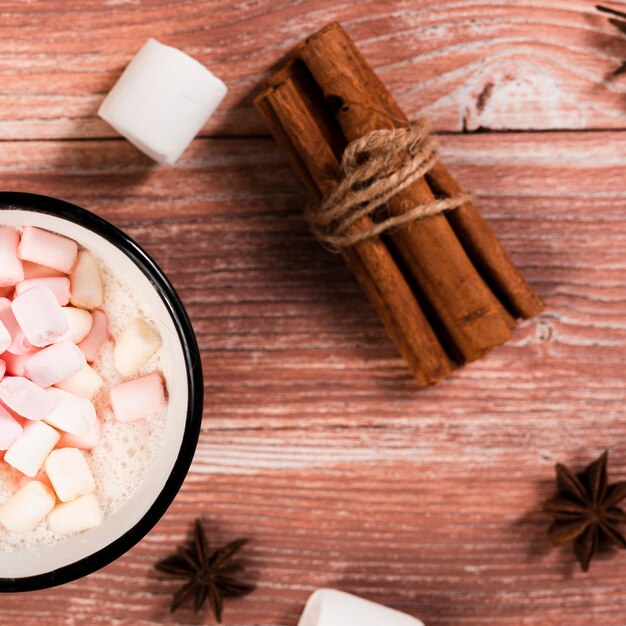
[0,191,204,593]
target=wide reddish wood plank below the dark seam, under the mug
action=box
[0,132,626,626]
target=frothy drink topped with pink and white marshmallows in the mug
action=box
[0,226,170,551]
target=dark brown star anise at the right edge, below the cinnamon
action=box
[544,452,626,572]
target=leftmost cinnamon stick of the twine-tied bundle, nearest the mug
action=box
[255,67,452,385]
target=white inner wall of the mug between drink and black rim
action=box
[0,204,197,589]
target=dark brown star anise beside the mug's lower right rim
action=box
[155,519,255,623]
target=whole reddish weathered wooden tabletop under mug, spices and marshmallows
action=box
[0,0,626,626]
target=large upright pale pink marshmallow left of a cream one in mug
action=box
[12,285,69,348]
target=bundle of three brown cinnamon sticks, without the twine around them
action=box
[255,22,543,385]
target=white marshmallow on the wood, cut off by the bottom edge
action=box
[298,589,424,626]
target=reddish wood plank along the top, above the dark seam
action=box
[0,0,626,140]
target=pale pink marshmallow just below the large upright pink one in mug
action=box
[24,341,87,387]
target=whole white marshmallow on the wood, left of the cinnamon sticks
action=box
[98,39,227,165]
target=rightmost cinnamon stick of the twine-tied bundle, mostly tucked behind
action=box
[329,23,544,319]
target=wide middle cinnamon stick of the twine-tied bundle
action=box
[294,23,511,361]
